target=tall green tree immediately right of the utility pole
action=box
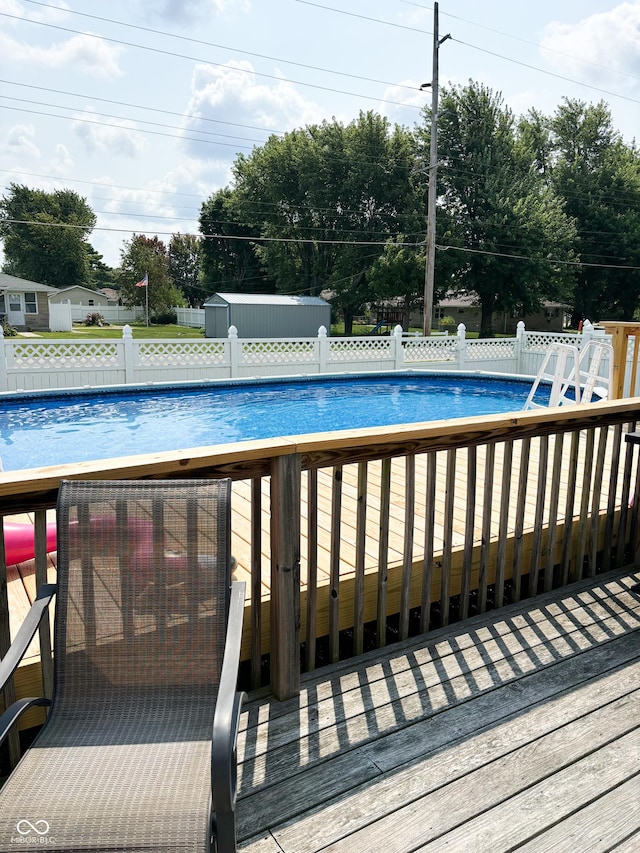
[430,81,575,336]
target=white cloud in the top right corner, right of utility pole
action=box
[541,2,640,89]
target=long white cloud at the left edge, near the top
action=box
[0,33,122,78]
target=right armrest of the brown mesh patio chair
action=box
[211,581,245,829]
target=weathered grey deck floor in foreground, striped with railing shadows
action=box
[238,570,640,853]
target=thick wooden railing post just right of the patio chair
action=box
[271,453,302,700]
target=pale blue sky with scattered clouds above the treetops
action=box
[0,0,640,266]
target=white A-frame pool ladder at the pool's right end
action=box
[524,340,613,409]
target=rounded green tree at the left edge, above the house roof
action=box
[0,183,96,287]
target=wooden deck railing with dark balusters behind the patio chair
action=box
[0,399,640,764]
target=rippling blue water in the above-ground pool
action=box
[0,374,544,471]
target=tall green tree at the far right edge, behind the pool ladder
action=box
[548,99,640,323]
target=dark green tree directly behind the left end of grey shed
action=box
[200,188,276,295]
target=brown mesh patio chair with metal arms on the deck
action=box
[0,480,244,853]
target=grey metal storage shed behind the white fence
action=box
[204,293,331,338]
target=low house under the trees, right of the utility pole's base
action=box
[433,294,568,335]
